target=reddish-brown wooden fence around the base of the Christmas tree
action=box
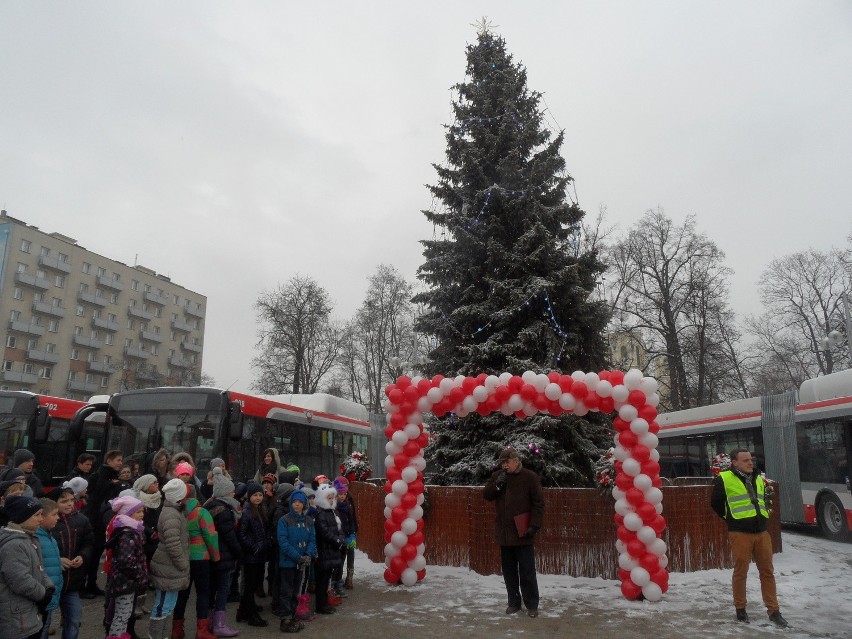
[350,482,781,579]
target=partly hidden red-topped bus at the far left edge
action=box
[0,391,103,486]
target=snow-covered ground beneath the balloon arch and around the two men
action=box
[347,531,852,639]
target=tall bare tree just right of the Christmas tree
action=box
[608,209,745,410]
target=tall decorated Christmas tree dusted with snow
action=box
[415,26,611,486]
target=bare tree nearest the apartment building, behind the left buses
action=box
[252,275,343,394]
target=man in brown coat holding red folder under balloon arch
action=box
[483,448,544,617]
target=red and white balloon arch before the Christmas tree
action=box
[384,369,669,601]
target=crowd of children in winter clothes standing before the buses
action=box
[0,449,357,639]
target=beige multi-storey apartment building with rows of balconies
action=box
[0,211,207,400]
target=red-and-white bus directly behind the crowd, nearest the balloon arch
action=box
[78,387,372,480]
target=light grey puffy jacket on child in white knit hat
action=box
[151,501,189,592]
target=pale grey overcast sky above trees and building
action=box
[0,0,852,396]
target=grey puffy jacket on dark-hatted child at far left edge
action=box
[0,524,53,639]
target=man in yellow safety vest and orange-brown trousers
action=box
[710,448,789,628]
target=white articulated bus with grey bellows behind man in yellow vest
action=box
[657,370,852,539]
